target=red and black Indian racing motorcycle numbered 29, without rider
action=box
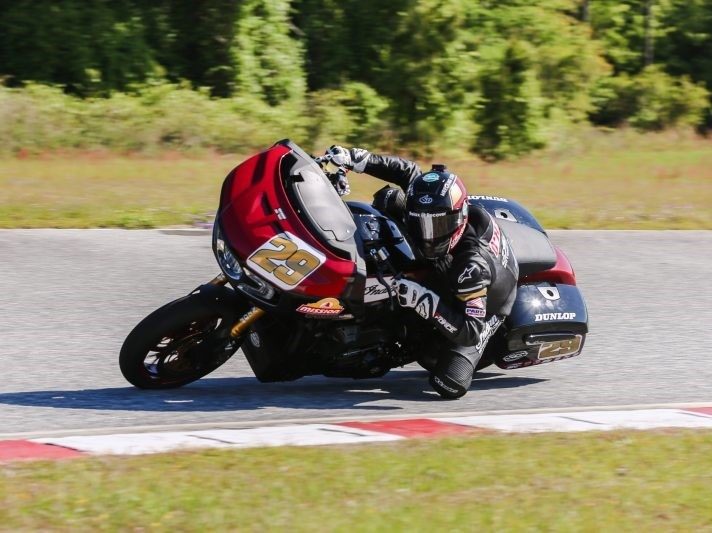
[119,140,588,389]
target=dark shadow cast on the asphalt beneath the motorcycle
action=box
[0,370,546,412]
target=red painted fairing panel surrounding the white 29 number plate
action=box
[218,144,356,298]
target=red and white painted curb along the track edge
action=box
[0,406,712,462]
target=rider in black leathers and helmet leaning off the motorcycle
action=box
[322,146,519,399]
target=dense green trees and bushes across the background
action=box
[0,0,712,159]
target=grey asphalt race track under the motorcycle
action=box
[0,230,712,437]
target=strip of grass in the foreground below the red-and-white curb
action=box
[0,431,712,532]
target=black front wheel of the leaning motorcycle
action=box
[119,292,248,389]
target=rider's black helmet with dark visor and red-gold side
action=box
[405,165,468,260]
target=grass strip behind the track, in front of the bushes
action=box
[0,135,712,229]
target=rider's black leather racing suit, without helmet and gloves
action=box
[357,151,519,398]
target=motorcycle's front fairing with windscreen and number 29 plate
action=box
[216,141,366,305]
